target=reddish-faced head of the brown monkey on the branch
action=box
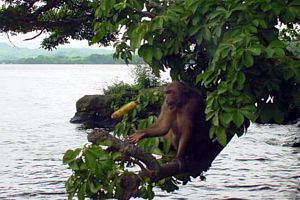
[164,82,189,108]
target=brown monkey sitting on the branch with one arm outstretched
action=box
[127,82,210,167]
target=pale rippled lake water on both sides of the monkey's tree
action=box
[0,65,300,200]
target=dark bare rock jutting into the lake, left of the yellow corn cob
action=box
[70,95,118,129]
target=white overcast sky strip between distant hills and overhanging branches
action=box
[0,32,112,49]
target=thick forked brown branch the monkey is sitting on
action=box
[88,129,231,200]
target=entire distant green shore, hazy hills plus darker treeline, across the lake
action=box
[0,43,143,64]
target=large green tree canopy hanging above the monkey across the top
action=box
[0,0,300,199]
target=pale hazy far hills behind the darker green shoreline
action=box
[0,43,114,61]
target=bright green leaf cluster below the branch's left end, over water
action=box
[63,141,127,199]
